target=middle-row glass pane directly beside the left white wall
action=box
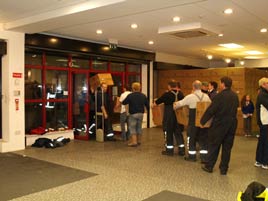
[24,68,42,100]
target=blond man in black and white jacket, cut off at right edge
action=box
[254,77,268,169]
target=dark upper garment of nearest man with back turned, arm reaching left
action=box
[200,88,239,125]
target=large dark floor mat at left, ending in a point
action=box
[0,153,96,201]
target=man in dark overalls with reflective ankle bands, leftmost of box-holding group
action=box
[154,81,185,156]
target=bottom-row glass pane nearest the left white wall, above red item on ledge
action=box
[25,103,42,133]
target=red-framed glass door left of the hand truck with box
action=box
[72,72,89,140]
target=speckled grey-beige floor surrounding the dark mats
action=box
[15,128,268,201]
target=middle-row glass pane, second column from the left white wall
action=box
[46,70,68,99]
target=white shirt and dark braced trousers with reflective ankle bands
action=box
[174,89,211,162]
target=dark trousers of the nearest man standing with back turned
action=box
[207,118,237,171]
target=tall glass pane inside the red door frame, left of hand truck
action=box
[73,74,88,136]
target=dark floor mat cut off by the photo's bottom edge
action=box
[143,191,208,201]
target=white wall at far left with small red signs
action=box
[0,29,25,152]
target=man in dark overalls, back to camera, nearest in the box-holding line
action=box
[200,77,239,175]
